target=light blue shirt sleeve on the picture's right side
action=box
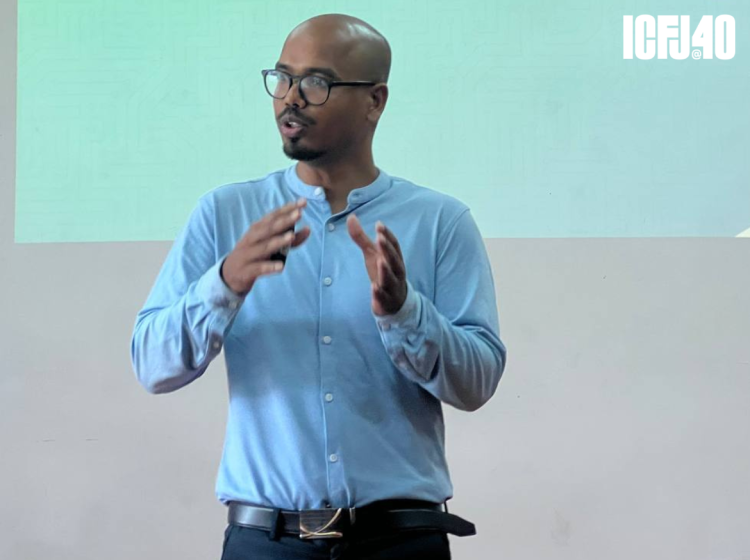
[373,208,507,411]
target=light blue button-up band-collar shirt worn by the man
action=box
[131,164,506,510]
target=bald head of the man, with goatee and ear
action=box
[273,14,391,165]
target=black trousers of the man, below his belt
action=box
[221,524,451,560]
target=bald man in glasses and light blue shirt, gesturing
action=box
[131,10,506,560]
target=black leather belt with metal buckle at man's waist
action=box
[228,500,476,539]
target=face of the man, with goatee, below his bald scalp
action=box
[273,34,367,161]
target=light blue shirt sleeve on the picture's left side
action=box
[130,196,245,393]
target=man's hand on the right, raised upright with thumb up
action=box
[346,213,407,315]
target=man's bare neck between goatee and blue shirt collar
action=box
[297,153,379,202]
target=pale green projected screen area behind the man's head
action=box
[15,0,750,243]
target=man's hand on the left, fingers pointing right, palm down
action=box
[220,198,310,296]
